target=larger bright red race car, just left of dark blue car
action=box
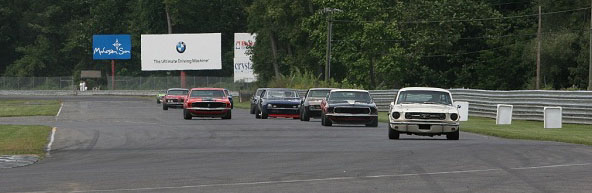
[183,88,232,119]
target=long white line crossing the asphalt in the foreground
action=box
[15,163,592,193]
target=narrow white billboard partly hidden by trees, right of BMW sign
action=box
[234,33,257,82]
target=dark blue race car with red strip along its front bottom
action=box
[255,88,301,119]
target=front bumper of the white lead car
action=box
[390,122,460,134]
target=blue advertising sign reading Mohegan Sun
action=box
[93,34,132,60]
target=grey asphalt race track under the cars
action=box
[0,96,592,193]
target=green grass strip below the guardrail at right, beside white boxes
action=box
[378,112,592,145]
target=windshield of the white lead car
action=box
[397,91,452,105]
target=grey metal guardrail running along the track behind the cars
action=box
[0,89,592,124]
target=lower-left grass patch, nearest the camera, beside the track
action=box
[0,125,51,156]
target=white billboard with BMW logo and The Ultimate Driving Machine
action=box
[141,33,222,71]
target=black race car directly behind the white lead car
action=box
[321,89,378,127]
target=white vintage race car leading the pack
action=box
[388,87,460,140]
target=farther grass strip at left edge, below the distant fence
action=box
[0,100,60,117]
